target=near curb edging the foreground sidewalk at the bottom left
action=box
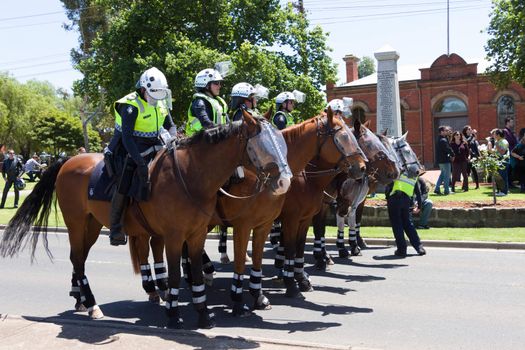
[0,314,352,350]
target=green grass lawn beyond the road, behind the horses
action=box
[0,177,525,242]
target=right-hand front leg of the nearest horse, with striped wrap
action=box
[186,232,215,328]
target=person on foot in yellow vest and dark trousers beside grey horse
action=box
[385,172,426,257]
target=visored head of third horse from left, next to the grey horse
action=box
[353,118,399,185]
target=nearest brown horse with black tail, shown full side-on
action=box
[0,113,289,328]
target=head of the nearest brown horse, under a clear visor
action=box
[243,110,293,195]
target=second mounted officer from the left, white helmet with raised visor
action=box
[186,68,229,136]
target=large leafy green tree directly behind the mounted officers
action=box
[63,0,335,123]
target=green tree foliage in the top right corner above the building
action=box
[485,0,525,88]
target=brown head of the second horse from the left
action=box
[316,107,366,178]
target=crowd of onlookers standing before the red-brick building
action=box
[434,118,525,197]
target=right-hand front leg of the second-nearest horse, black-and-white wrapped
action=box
[250,223,272,310]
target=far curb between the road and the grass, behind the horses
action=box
[0,225,525,250]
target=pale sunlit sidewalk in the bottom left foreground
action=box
[0,315,352,350]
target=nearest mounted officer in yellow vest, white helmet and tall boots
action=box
[105,67,177,245]
